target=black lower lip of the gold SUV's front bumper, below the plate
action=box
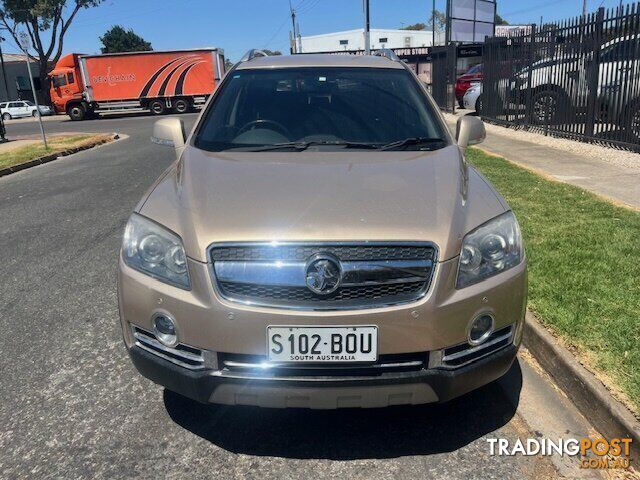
[129,343,518,409]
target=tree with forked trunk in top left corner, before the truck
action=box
[0,0,102,101]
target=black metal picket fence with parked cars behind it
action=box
[477,4,640,151]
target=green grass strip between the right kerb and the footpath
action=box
[467,149,640,412]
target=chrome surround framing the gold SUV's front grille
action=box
[207,240,440,312]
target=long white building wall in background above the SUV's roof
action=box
[301,28,432,53]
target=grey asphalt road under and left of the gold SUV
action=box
[0,115,586,480]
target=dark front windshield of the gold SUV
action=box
[195,67,447,151]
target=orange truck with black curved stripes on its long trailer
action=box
[50,48,224,120]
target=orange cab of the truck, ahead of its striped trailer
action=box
[49,53,84,113]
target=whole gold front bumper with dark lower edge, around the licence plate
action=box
[118,251,527,409]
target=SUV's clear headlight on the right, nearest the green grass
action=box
[456,212,524,288]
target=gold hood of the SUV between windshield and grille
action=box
[137,145,506,262]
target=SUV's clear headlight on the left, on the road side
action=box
[122,213,190,289]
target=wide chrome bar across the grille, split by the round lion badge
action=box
[213,259,433,287]
